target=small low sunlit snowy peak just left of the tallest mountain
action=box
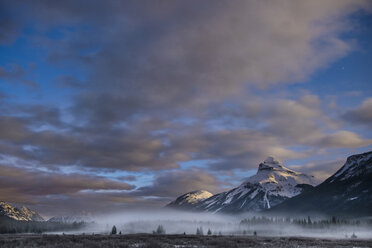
[167,190,213,209]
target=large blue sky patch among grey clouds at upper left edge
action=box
[0,28,87,107]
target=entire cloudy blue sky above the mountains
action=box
[0,0,372,216]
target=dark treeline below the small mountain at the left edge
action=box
[0,218,86,234]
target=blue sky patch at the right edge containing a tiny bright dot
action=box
[288,13,372,107]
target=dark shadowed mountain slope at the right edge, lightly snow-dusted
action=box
[272,151,372,216]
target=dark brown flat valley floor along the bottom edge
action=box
[0,234,372,248]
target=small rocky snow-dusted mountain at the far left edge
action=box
[0,201,44,221]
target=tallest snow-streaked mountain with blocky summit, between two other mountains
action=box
[167,157,319,213]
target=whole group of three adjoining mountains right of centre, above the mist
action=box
[167,152,372,216]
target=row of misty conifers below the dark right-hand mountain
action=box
[240,216,372,228]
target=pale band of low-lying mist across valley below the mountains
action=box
[56,209,372,238]
